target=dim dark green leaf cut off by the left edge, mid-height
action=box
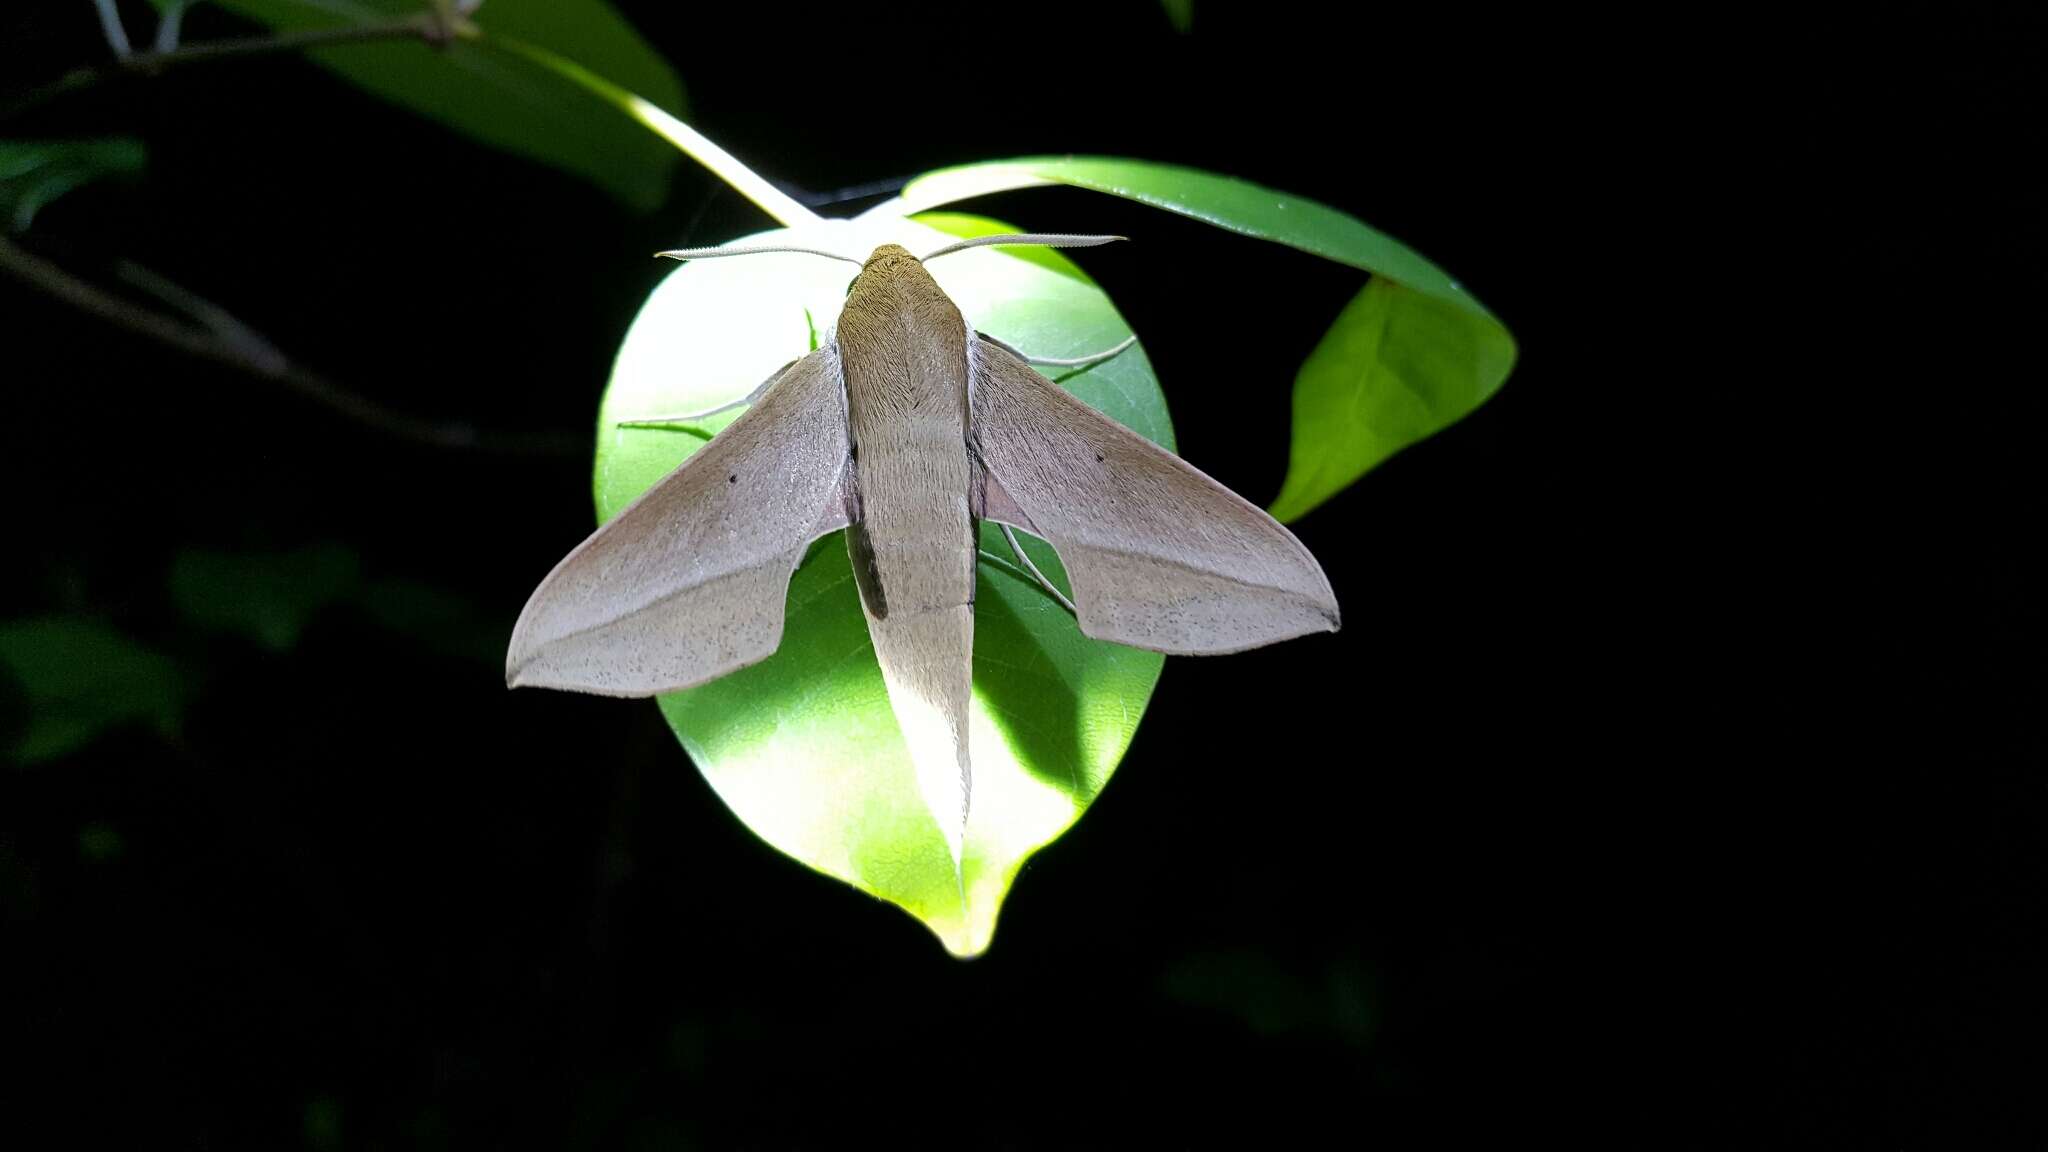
[0,617,184,765]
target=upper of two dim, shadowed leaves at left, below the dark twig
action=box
[170,543,360,652]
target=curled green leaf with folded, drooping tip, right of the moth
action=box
[868,156,1516,521]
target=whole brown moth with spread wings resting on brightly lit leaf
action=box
[506,234,1337,869]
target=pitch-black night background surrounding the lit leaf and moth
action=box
[0,4,2048,1148]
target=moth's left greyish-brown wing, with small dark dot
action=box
[506,344,850,697]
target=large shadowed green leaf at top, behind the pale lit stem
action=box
[154,0,682,211]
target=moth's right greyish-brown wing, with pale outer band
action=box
[969,340,1337,656]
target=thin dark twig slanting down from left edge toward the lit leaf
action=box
[0,236,588,455]
